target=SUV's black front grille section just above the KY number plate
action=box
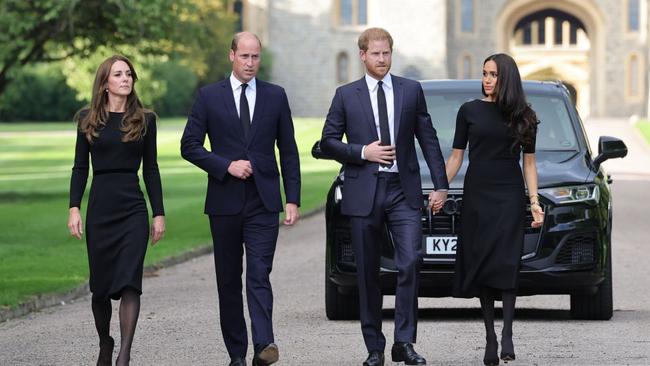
[422,194,545,235]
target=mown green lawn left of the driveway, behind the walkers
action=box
[0,119,339,307]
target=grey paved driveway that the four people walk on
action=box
[0,118,650,366]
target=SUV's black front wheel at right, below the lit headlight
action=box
[571,241,614,320]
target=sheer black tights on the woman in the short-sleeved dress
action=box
[480,287,517,354]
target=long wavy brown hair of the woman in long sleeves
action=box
[74,55,147,143]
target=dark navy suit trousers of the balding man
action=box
[210,177,279,358]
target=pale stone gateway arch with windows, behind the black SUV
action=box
[495,0,605,117]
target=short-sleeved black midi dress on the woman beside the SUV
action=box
[453,100,535,298]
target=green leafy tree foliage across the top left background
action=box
[0,0,234,95]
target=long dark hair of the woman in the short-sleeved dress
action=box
[481,53,539,150]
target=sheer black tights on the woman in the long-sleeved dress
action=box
[92,288,140,366]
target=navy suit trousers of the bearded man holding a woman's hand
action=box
[350,172,422,352]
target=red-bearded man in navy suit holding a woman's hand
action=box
[320,28,448,366]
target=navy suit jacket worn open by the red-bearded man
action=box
[320,75,449,216]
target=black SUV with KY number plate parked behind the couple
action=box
[312,80,627,320]
